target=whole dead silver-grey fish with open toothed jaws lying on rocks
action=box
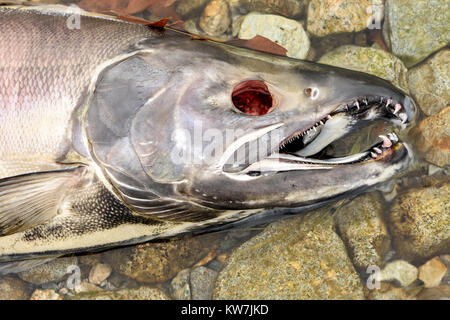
[0,7,415,268]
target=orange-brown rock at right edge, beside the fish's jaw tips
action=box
[411,105,450,167]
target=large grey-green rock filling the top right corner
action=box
[383,0,450,68]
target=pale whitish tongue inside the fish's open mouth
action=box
[295,114,351,157]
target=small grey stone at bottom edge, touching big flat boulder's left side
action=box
[190,267,217,300]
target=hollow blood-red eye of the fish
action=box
[231,80,273,116]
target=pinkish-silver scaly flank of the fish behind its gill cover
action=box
[0,7,153,178]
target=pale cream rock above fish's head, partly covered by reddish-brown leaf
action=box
[238,13,310,59]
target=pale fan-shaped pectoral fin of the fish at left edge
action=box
[0,168,82,235]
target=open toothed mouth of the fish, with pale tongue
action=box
[223,96,410,177]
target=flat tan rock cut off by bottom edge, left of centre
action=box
[71,286,170,300]
